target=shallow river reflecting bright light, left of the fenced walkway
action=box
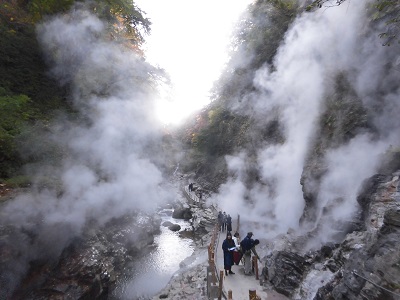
[113,209,194,300]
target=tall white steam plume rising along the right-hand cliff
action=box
[214,1,400,247]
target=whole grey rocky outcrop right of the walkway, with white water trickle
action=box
[266,172,400,300]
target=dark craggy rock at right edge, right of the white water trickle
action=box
[314,175,400,300]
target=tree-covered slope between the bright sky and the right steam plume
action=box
[178,0,298,181]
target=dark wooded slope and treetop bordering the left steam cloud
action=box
[0,0,150,185]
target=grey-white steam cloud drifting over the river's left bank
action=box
[0,5,174,290]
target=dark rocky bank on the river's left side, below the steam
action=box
[0,215,160,299]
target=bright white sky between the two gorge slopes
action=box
[134,0,252,124]
